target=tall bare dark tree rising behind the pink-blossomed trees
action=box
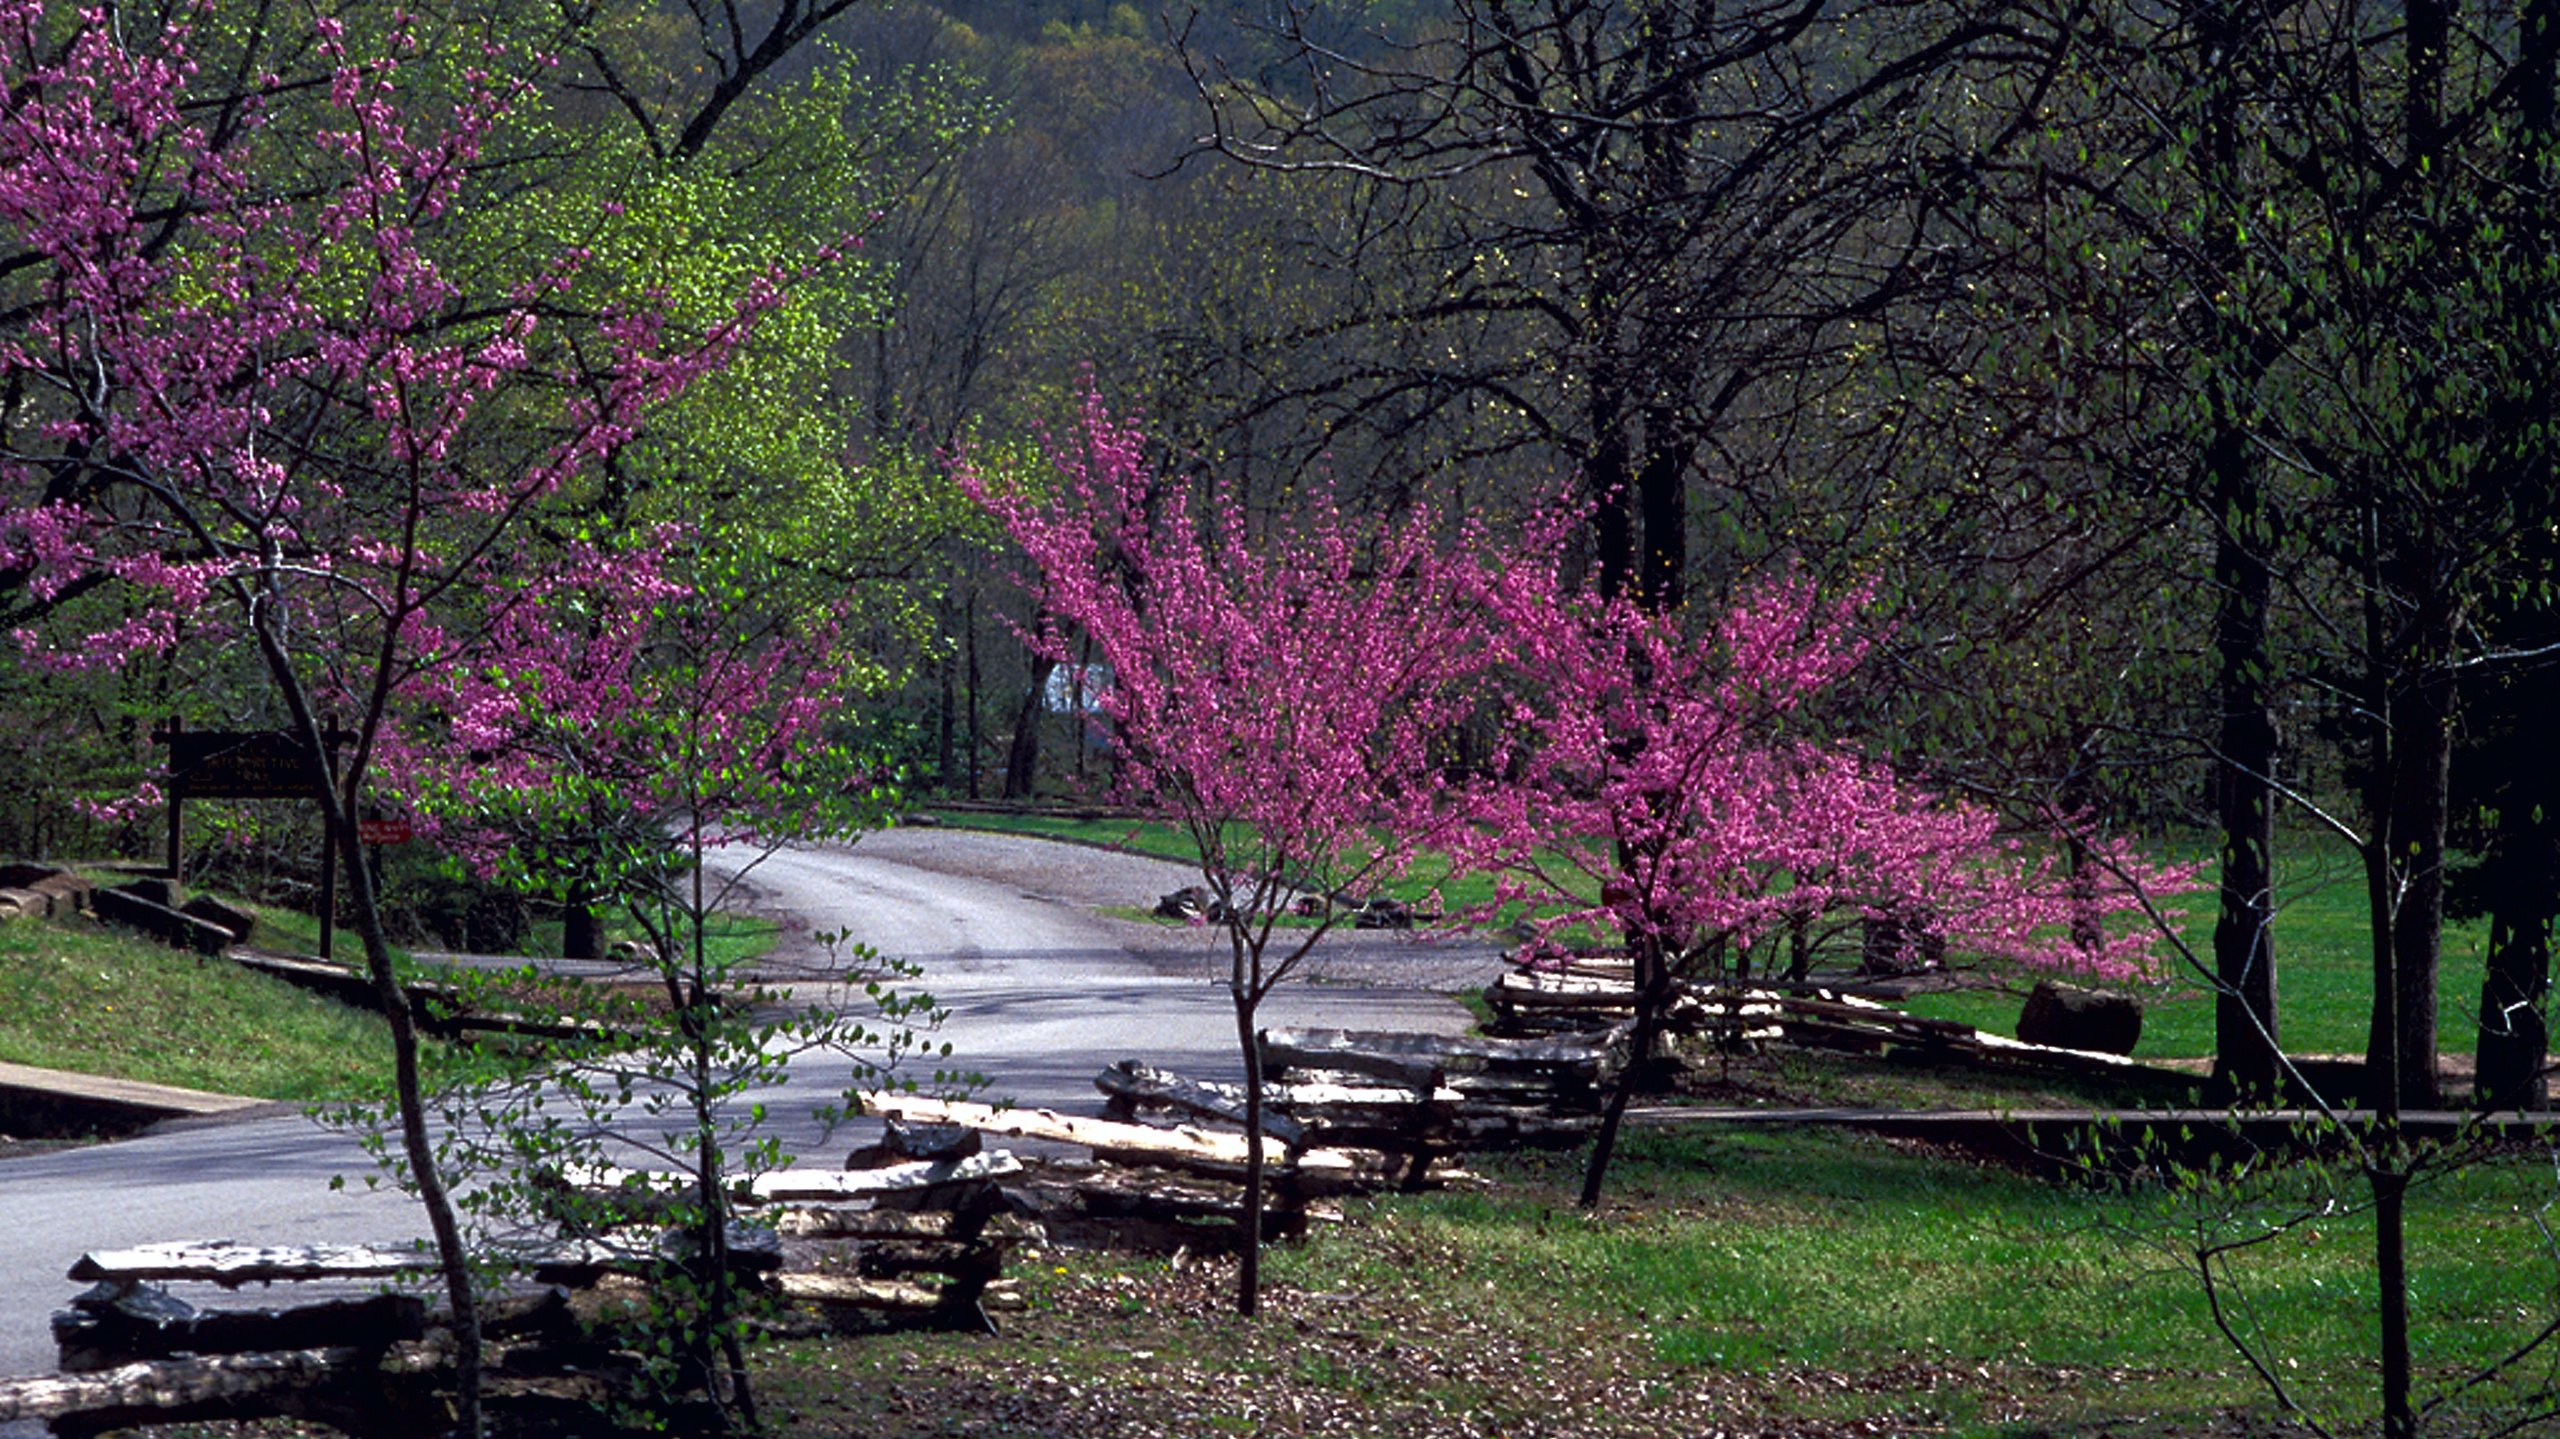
[1196,0,2058,607]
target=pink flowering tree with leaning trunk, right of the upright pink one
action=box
[1464,563,2186,1203]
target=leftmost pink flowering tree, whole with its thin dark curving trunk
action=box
[0,11,808,1431]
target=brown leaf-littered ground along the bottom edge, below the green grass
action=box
[768,1239,2324,1439]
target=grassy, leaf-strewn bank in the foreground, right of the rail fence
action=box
[771,1132,2552,1439]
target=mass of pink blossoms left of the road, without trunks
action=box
[0,0,837,839]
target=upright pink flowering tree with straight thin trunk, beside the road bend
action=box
[960,399,1495,1314]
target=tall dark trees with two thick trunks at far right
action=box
[2051,5,2555,1106]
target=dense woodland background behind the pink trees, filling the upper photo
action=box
[0,0,2560,1104]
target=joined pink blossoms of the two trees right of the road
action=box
[960,399,2191,978]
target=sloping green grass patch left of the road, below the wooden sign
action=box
[0,919,392,1101]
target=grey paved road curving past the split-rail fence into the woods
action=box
[0,830,1492,1382]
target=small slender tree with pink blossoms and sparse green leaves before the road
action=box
[381,527,950,1431]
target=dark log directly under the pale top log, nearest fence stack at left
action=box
[54,1285,428,1372]
